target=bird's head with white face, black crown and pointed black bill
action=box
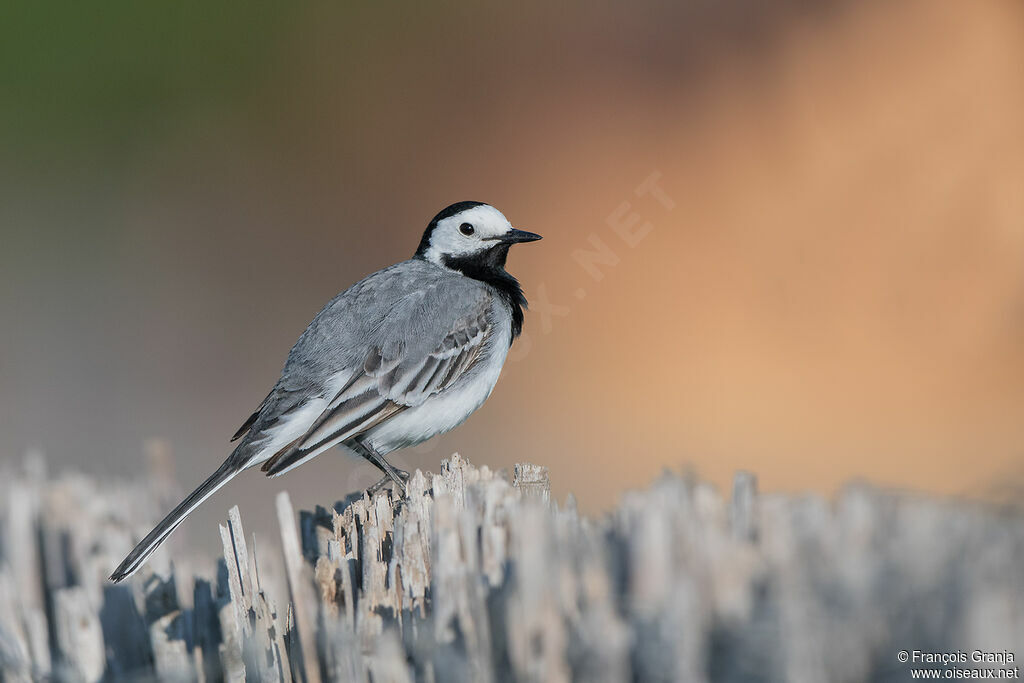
[416,202,541,270]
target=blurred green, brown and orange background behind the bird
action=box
[0,0,1024,549]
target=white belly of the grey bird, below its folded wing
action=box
[364,325,512,454]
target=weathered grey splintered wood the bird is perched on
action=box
[0,455,1024,683]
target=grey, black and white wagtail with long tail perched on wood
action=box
[111,202,541,582]
